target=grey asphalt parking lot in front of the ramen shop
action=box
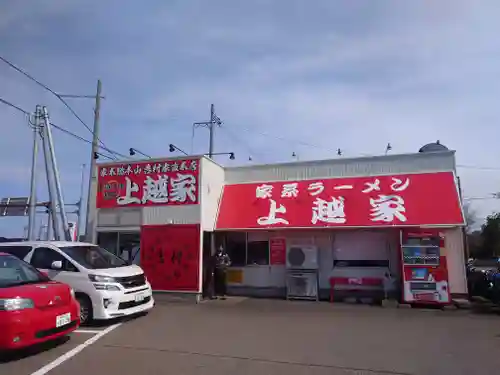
[0,298,500,375]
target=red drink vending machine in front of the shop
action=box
[401,230,451,305]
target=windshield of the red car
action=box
[0,255,49,288]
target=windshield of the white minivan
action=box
[60,245,128,270]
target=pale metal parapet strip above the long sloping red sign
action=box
[225,151,455,184]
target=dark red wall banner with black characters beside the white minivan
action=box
[140,224,200,292]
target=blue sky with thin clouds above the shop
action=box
[0,0,500,235]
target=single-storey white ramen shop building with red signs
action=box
[89,145,467,301]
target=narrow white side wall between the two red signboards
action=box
[200,158,224,231]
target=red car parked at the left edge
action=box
[0,253,80,350]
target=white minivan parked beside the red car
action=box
[0,241,154,324]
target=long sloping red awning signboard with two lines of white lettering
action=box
[217,172,464,229]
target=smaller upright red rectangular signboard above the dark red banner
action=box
[96,159,200,208]
